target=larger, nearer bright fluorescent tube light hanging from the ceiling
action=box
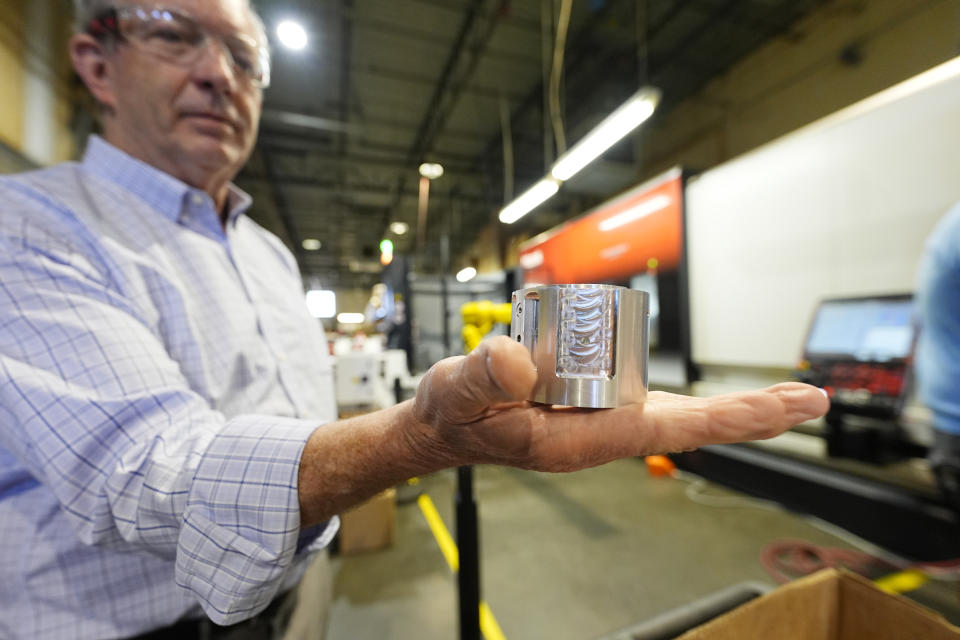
[550,87,660,182]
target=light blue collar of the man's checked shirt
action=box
[82,135,253,225]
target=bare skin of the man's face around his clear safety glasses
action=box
[101,0,261,188]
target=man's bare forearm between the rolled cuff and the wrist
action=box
[298,401,456,527]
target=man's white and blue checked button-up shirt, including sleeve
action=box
[0,137,337,639]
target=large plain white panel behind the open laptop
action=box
[686,58,960,367]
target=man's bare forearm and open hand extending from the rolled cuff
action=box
[297,337,829,527]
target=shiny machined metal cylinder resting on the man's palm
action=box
[510,284,650,408]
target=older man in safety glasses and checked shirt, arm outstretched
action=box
[0,0,827,639]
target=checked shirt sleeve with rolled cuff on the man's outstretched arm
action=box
[0,226,326,624]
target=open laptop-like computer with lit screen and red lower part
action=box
[798,294,917,417]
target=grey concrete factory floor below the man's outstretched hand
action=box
[328,459,960,640]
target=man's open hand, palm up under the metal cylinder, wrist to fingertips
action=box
[413,337,830,471]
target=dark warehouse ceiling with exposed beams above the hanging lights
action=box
[238,0,824,289]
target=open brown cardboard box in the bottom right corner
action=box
[677,569,960,640]
